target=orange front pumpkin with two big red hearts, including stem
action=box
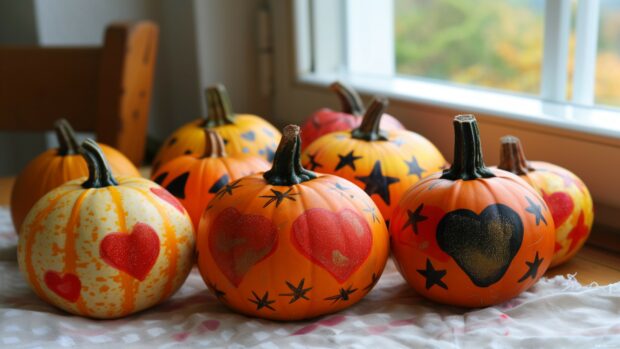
[196,125,389,320]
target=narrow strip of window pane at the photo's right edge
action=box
[595,0,620,106]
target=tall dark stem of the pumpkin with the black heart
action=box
[440,115,495,181]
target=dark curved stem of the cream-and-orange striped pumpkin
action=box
[80,139,118,189]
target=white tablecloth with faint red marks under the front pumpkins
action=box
[0,207,620,349]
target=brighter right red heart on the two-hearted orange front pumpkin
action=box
[292,208,372,283]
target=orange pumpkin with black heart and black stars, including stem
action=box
[390,115,555,307]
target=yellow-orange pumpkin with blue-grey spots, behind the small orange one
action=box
[153,85,281,173]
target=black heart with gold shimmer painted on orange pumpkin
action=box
[437,204,523,287]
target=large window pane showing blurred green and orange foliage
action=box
[394,0,544,94]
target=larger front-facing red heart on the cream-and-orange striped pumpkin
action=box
[99,223,160,281]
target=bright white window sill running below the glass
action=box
[298,74,620,143]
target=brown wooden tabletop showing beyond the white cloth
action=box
[0,174,620,285]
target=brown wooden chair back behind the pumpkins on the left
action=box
[0,21,159,165]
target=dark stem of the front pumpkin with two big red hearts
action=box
[263,125,316,186]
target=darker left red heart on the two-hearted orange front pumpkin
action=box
[209,207,278,287]
